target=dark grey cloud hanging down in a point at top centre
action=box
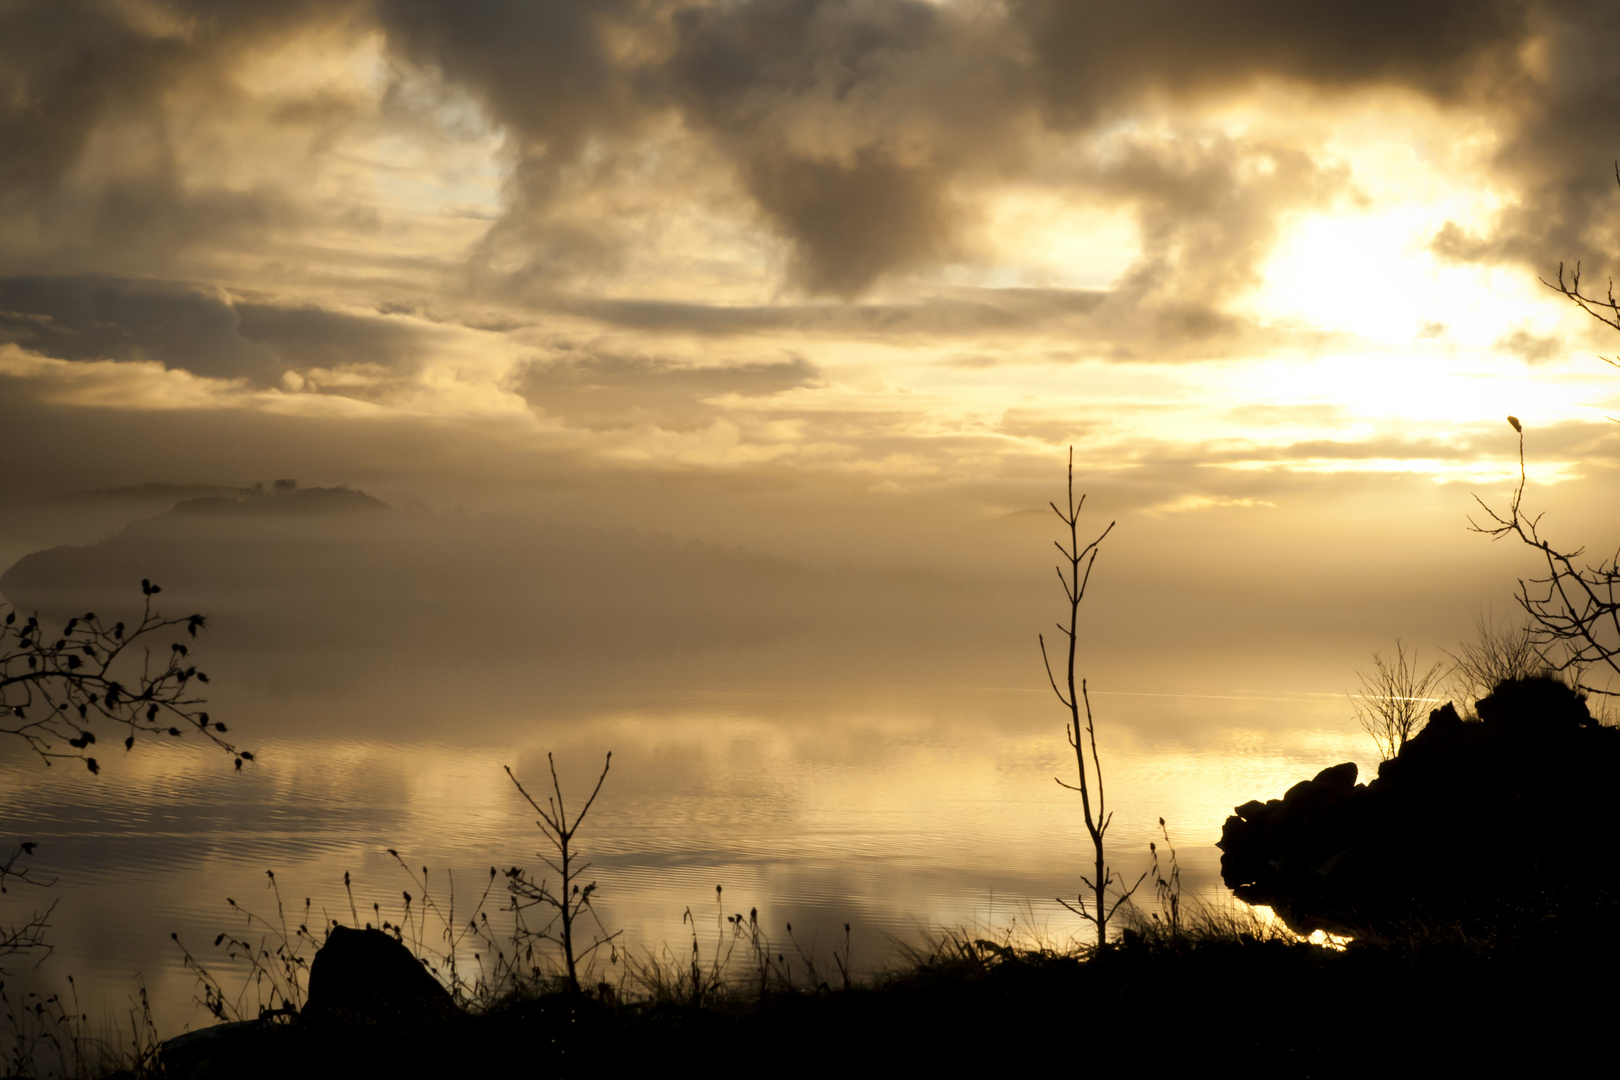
[659,0,1019,296]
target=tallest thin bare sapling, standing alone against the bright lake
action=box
[1038,447,1147,947]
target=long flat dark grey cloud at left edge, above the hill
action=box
[0,275,437,385]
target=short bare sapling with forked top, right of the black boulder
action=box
[505,753,624,994]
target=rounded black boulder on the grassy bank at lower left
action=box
[303,926,455,1028]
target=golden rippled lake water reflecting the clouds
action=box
[0,687,1367,1033]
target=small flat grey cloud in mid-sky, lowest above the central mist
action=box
[517,353,821,431]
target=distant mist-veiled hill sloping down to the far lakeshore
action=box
[0,487,1029,733]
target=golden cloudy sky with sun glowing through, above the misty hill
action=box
[0,0,1620,702]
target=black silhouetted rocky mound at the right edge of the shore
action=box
[1220,677,1620,934]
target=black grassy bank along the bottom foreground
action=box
[154,931,1617,1080]
